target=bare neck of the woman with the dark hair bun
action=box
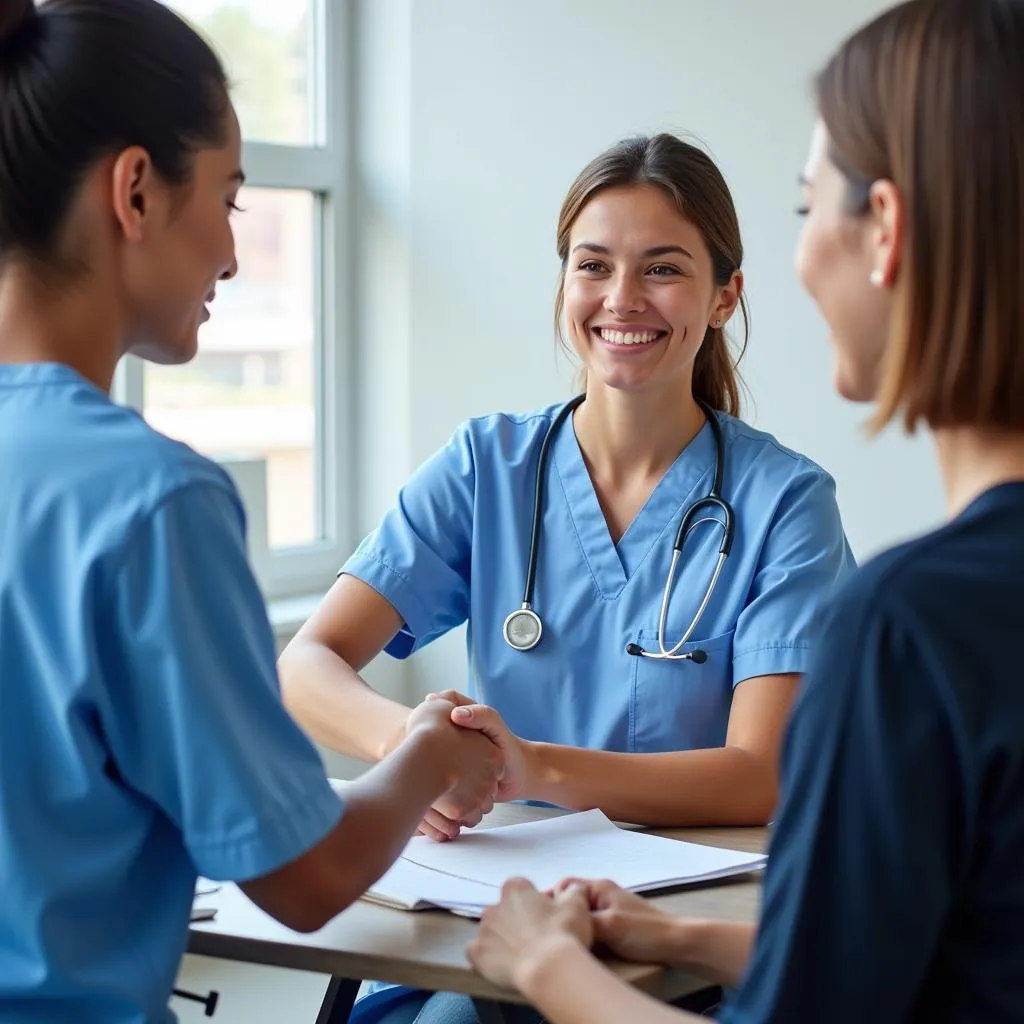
[0,265,123,391]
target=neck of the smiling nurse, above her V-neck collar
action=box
[572,384,705,484]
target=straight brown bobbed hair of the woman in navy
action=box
[817,0,1024,431]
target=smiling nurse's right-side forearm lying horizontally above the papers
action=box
[525,743,777,826]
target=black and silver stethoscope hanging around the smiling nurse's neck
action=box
[502,394,735,665]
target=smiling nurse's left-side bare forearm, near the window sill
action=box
[278,637,409,762]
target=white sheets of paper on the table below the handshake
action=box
[364,811,766,918]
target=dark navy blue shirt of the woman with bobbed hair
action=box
[722,483,1024,1024]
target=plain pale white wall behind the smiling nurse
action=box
[175,0,942,1024]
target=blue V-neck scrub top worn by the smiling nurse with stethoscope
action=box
[342,407,854,752]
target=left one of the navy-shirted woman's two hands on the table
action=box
[466,879,594,988]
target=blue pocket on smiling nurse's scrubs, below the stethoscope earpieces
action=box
[630,628,733,754]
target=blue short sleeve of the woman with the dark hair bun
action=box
[101,483,342,882]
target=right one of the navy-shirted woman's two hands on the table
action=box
[554,879,686,964]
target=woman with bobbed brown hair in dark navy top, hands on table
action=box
[468,0,1024,1024]
